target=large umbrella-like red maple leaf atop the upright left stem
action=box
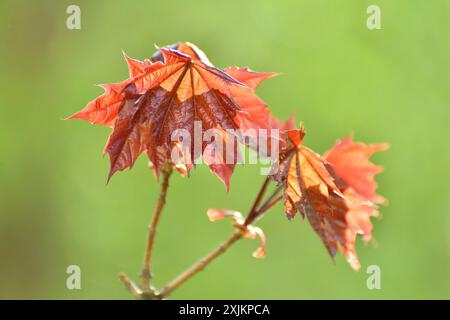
[69,43,284,188]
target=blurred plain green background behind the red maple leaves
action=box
[0,0,450,299]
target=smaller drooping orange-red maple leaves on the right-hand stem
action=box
[274,129,386,269]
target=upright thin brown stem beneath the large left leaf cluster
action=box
[141,165,172,291]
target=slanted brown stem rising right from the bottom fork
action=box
[159,229,244,299]
